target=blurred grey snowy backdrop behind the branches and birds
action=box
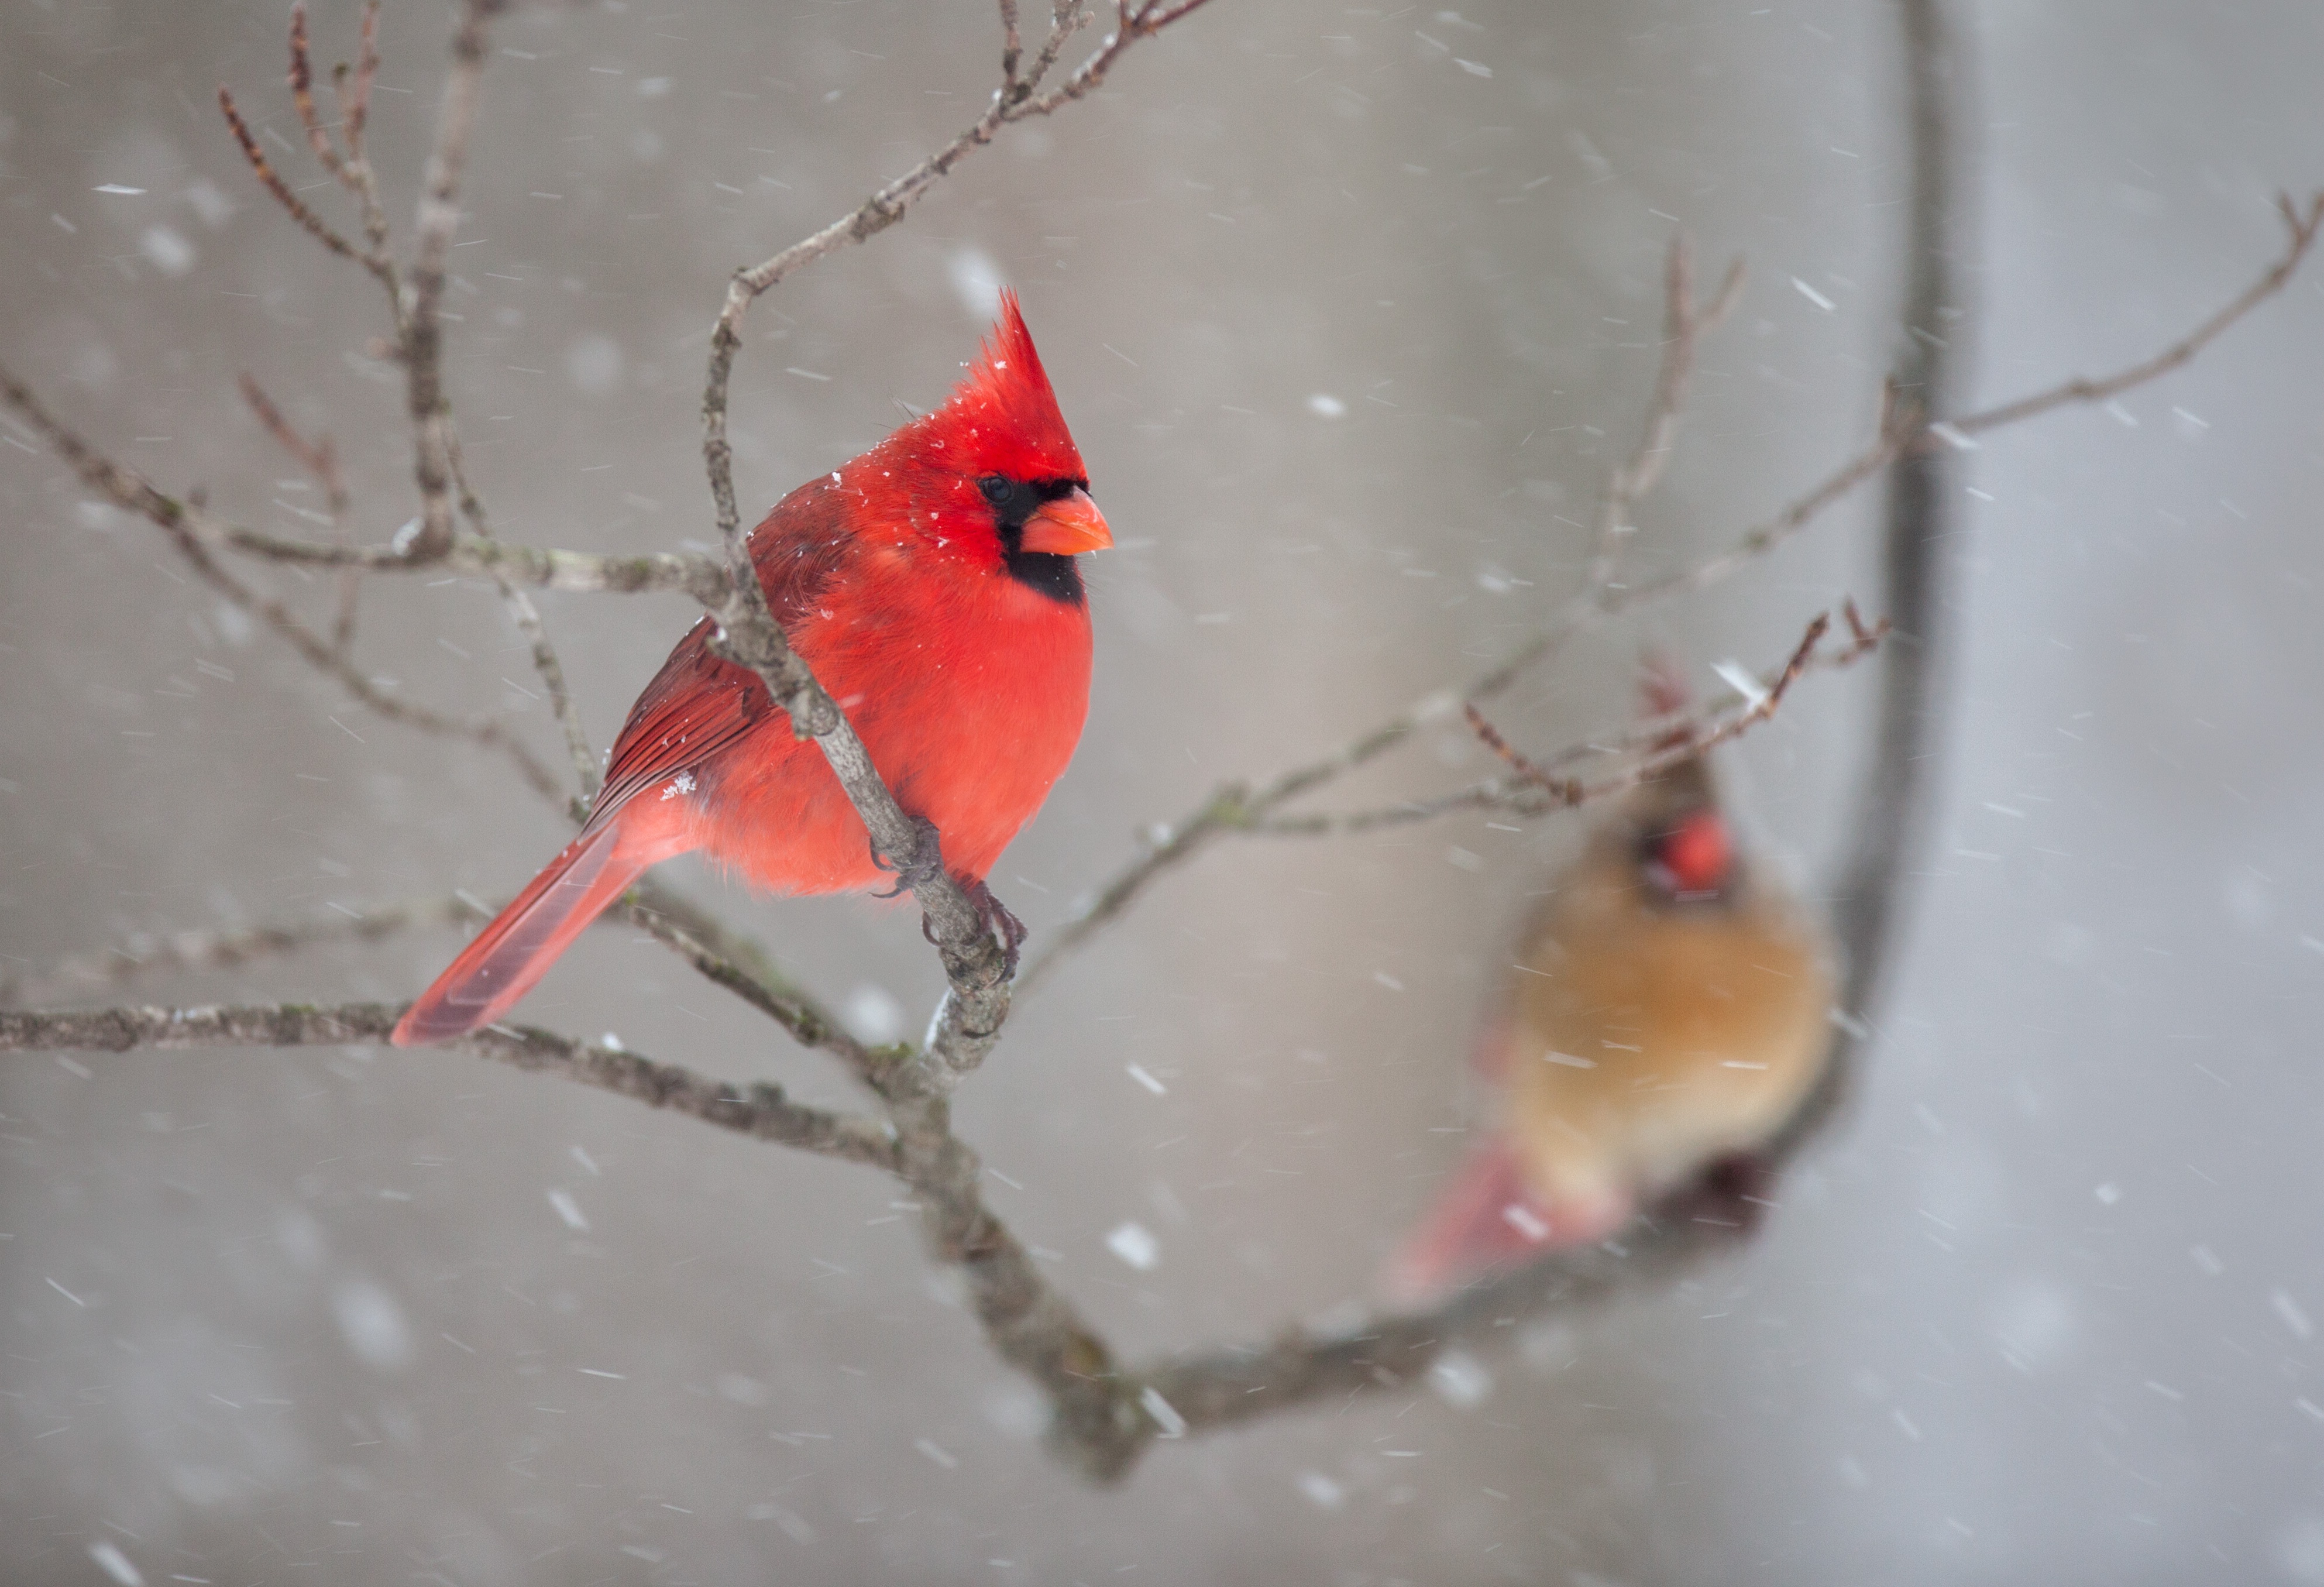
[0,0,2324,1587]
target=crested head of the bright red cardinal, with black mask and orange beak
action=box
[858,293,1113,606]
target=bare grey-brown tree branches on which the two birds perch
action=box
[0,0,2324,1475]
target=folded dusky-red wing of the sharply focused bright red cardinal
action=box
[588,476,855,827]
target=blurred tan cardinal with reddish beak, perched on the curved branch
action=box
[1385,667,1834,1304]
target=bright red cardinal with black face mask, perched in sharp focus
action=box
[393,293,1113,1046]
